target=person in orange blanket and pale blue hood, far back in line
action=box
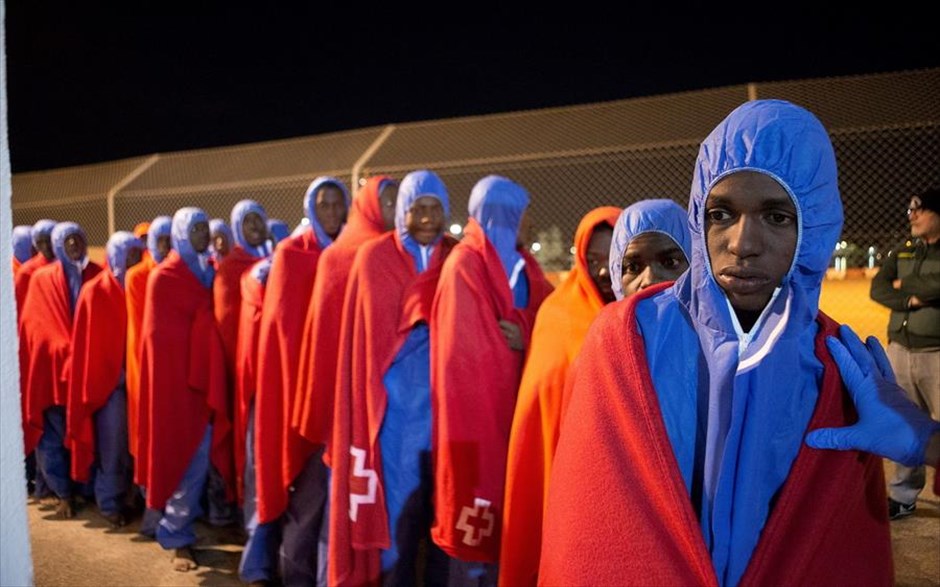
[124,216,173,466]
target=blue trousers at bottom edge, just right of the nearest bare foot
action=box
[238,404,281,583]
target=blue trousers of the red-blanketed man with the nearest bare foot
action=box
[156,424,212,550]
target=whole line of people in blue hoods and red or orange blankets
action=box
[14,100,940,586]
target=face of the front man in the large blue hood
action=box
[705,171,797,329]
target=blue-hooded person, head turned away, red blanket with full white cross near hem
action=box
[430,175,553,564]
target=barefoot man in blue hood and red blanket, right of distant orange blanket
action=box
[135,207,234,570]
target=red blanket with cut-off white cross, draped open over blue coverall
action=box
[329,233,454,585]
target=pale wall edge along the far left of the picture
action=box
[0,0,33,585]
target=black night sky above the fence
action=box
[6,5,940,173]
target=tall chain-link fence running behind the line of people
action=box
[13,68,940,336]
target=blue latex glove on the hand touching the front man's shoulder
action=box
[806,325,940,467]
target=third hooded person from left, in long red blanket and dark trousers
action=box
[20,222,101,517]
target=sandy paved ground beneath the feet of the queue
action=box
[23,470,940,587]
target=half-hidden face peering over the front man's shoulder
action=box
[620,232,689,298]
